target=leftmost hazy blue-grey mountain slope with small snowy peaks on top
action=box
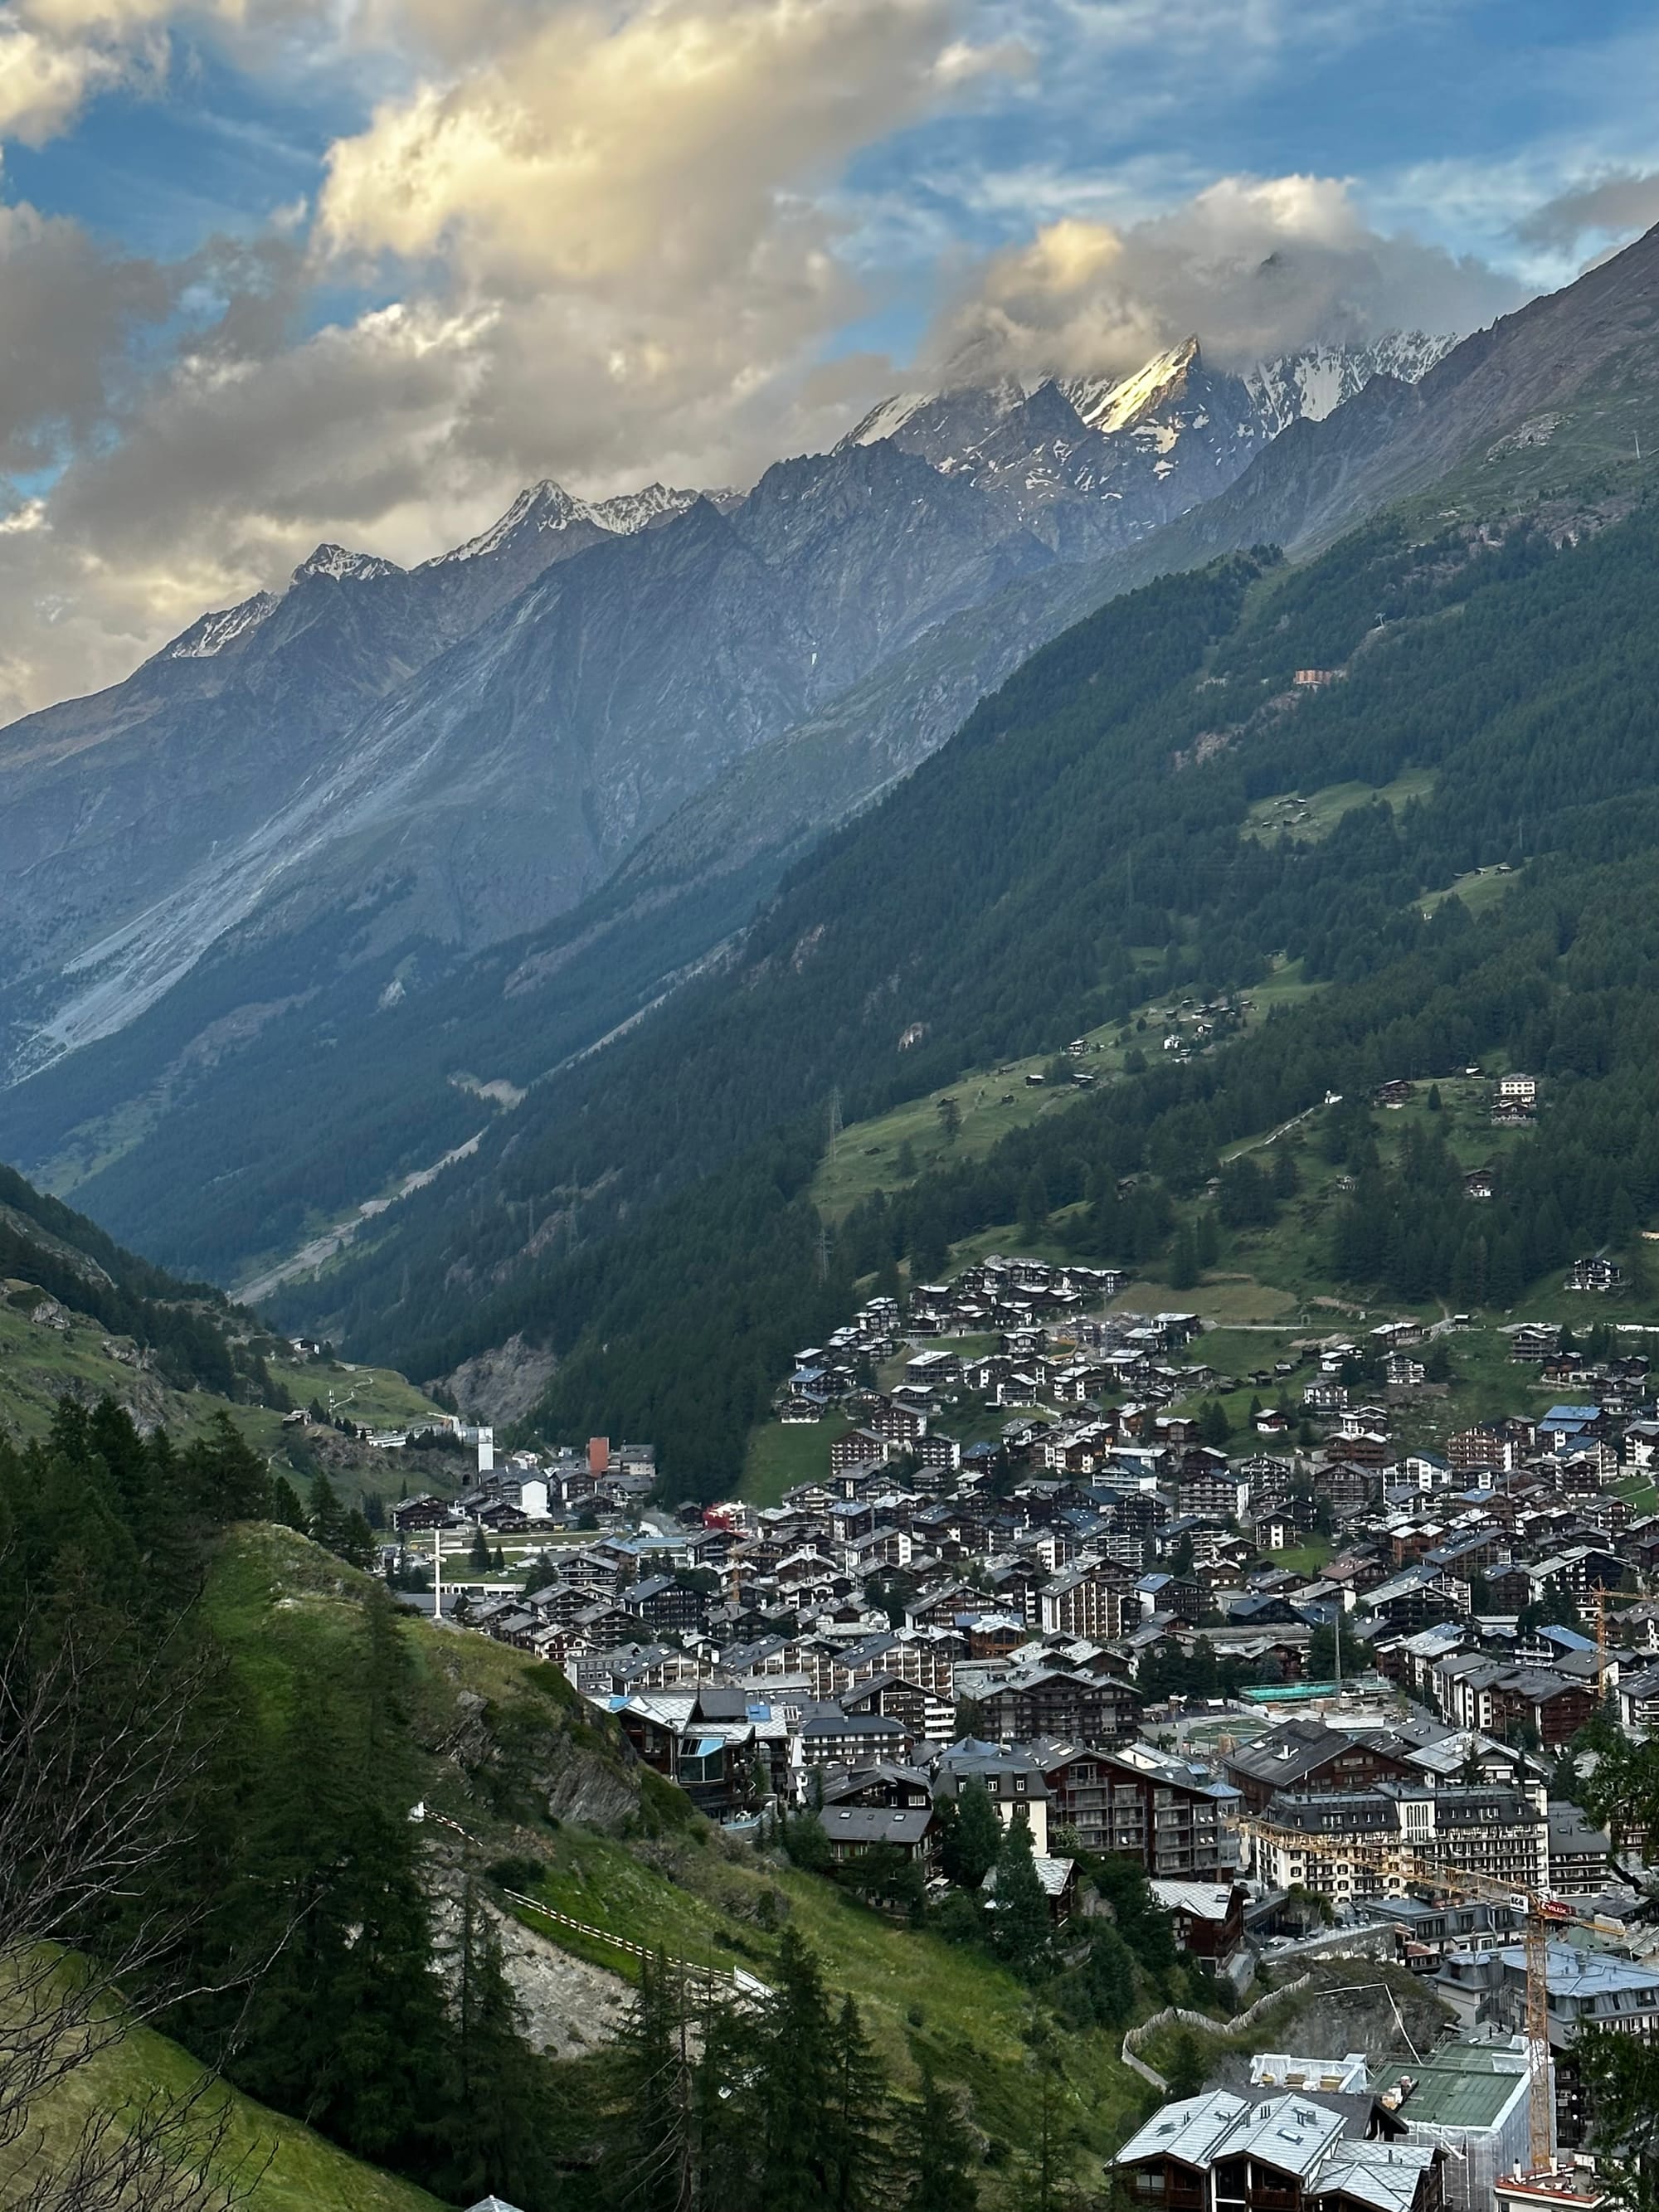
[0,484,693,1075]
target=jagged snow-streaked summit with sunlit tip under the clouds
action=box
[843,332,1456,560]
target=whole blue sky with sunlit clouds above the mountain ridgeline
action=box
[0,0,1659,707]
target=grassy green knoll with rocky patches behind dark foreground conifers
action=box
[206,1529,1194,2205]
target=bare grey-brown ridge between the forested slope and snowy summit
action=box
[601,232,1659,960]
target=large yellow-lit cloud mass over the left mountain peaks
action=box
[0,0,1019,710]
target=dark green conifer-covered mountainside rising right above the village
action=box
[260,491,1659,1495]
